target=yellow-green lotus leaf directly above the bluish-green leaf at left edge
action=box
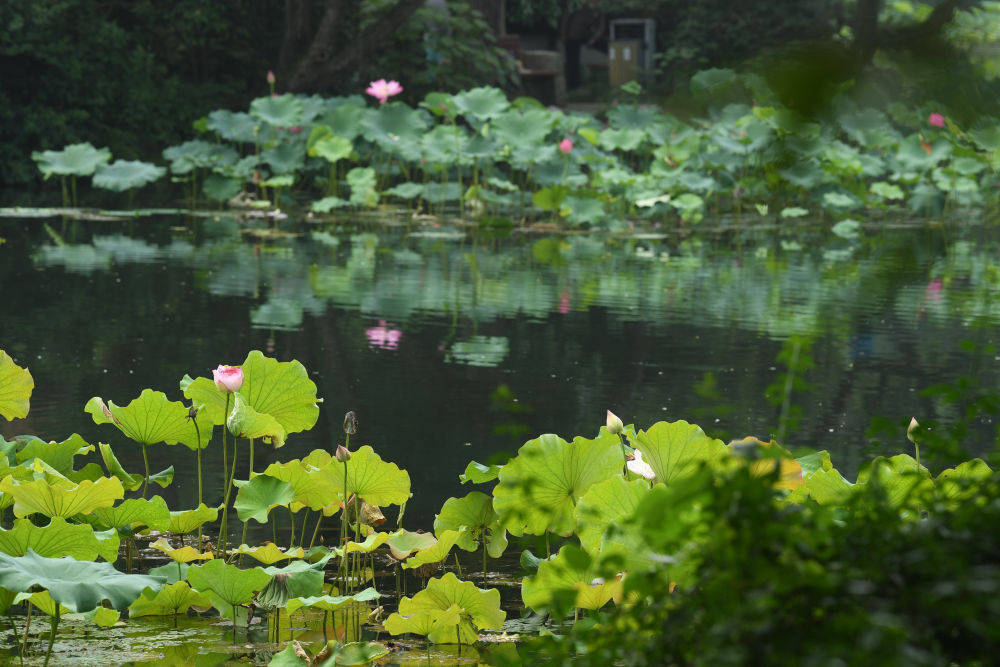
[0,517,120,563]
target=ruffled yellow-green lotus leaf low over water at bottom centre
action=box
[399,572,507,644]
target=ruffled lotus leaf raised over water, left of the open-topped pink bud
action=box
[84,389,212,449]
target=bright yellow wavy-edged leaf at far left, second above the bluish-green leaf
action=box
[0,477,125,518]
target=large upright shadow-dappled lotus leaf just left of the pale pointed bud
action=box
[493,429,624,536]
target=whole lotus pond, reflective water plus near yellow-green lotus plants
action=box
[0,211,1000,665]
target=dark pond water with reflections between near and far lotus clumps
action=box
[0,211,1000,528]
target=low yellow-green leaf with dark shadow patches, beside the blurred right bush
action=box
[521,544,621,611]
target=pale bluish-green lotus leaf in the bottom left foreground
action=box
[0,550,162,612]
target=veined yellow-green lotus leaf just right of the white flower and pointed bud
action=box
[629,420,729,484]
